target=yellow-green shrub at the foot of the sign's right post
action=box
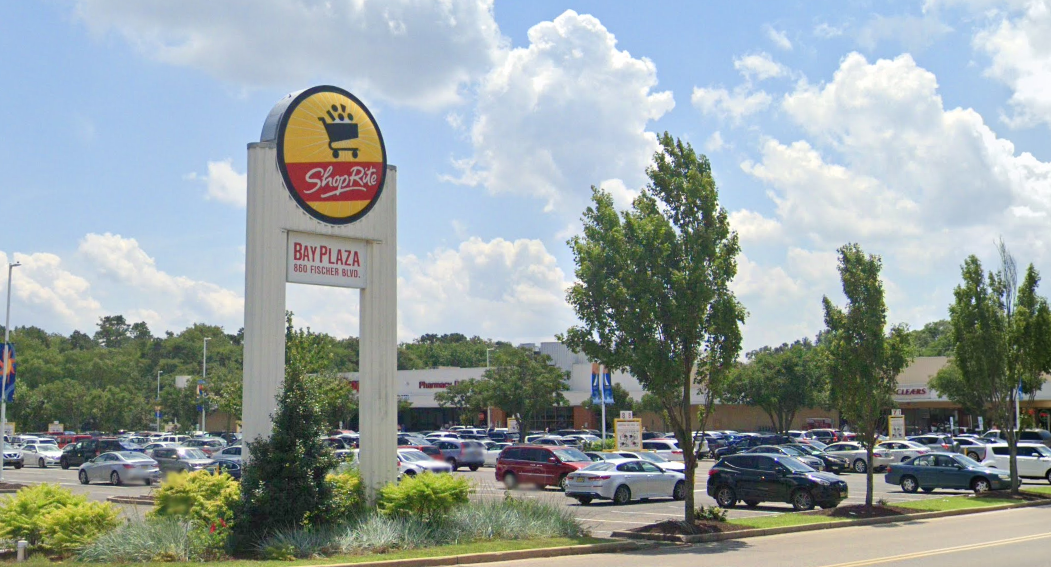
[378,472,471,520]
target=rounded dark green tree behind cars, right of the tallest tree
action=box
[724,339,828,433]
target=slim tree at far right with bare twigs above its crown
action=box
[946,245,1051,493]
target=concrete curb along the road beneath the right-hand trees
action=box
[612,500,1051,544]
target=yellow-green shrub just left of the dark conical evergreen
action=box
[150,470,241,528]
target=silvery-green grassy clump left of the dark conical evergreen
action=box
[78,517,202,563]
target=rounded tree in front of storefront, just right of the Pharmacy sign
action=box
[476,347,570,439]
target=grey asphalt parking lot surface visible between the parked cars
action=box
[4,461,1047,536]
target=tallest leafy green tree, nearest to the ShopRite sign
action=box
[563,133,746,522]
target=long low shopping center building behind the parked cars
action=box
[345,342,1051,432]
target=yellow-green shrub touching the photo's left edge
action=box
[0,484,87,545]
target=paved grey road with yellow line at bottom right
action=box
[481,506,1051,567]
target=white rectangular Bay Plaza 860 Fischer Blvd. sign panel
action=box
[286,231,368,289]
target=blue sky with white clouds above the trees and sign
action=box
[0,0,1051,349]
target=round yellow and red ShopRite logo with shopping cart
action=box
[277,86,387,224]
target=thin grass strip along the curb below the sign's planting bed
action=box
[22,538,612,567]
